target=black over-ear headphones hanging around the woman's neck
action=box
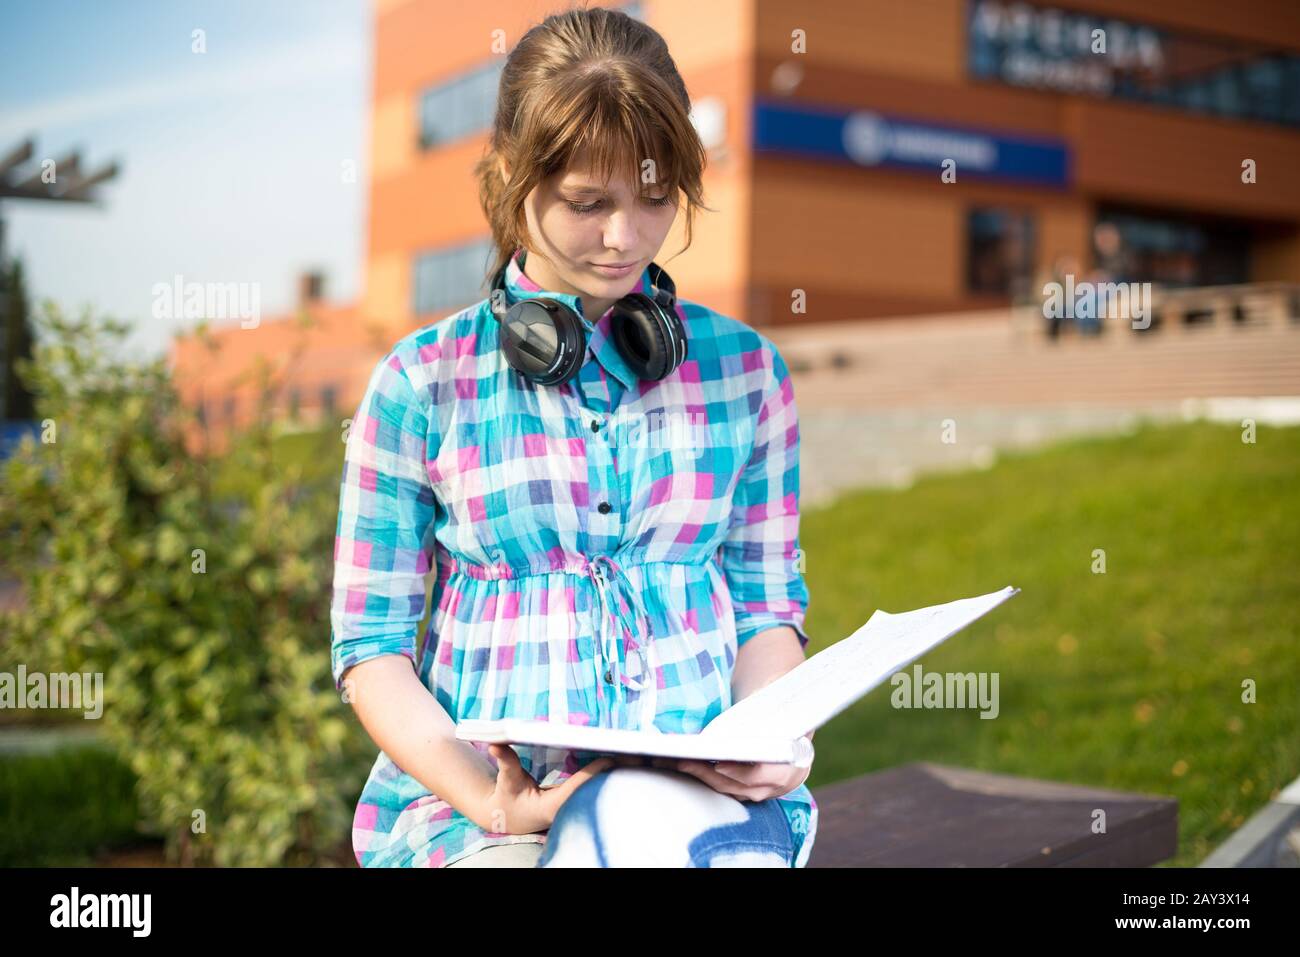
[488,251,686,385]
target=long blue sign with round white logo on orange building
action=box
[754,100,1070,186]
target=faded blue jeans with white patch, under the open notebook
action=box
[536,766,795,867]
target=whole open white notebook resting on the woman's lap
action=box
[456,585,1021,767]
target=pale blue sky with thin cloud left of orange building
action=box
[0,0,372,354]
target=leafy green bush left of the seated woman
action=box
[0,303,374,866]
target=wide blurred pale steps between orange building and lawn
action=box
[764,299,1300,506]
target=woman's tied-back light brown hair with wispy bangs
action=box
[475,7,709,283]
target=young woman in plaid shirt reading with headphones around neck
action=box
[332,1,816,867]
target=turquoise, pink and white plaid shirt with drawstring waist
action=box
[330,252,816,867]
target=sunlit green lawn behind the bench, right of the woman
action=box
[801,423,1300,866]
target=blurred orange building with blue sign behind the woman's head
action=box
[170,0,1300,447]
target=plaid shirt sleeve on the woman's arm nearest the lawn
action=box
[719,338,809,648]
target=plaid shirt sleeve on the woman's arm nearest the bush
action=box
[330,354,434,690]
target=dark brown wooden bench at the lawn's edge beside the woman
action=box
[807,762,1178,867]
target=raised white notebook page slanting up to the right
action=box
[699,585,1021,737]
